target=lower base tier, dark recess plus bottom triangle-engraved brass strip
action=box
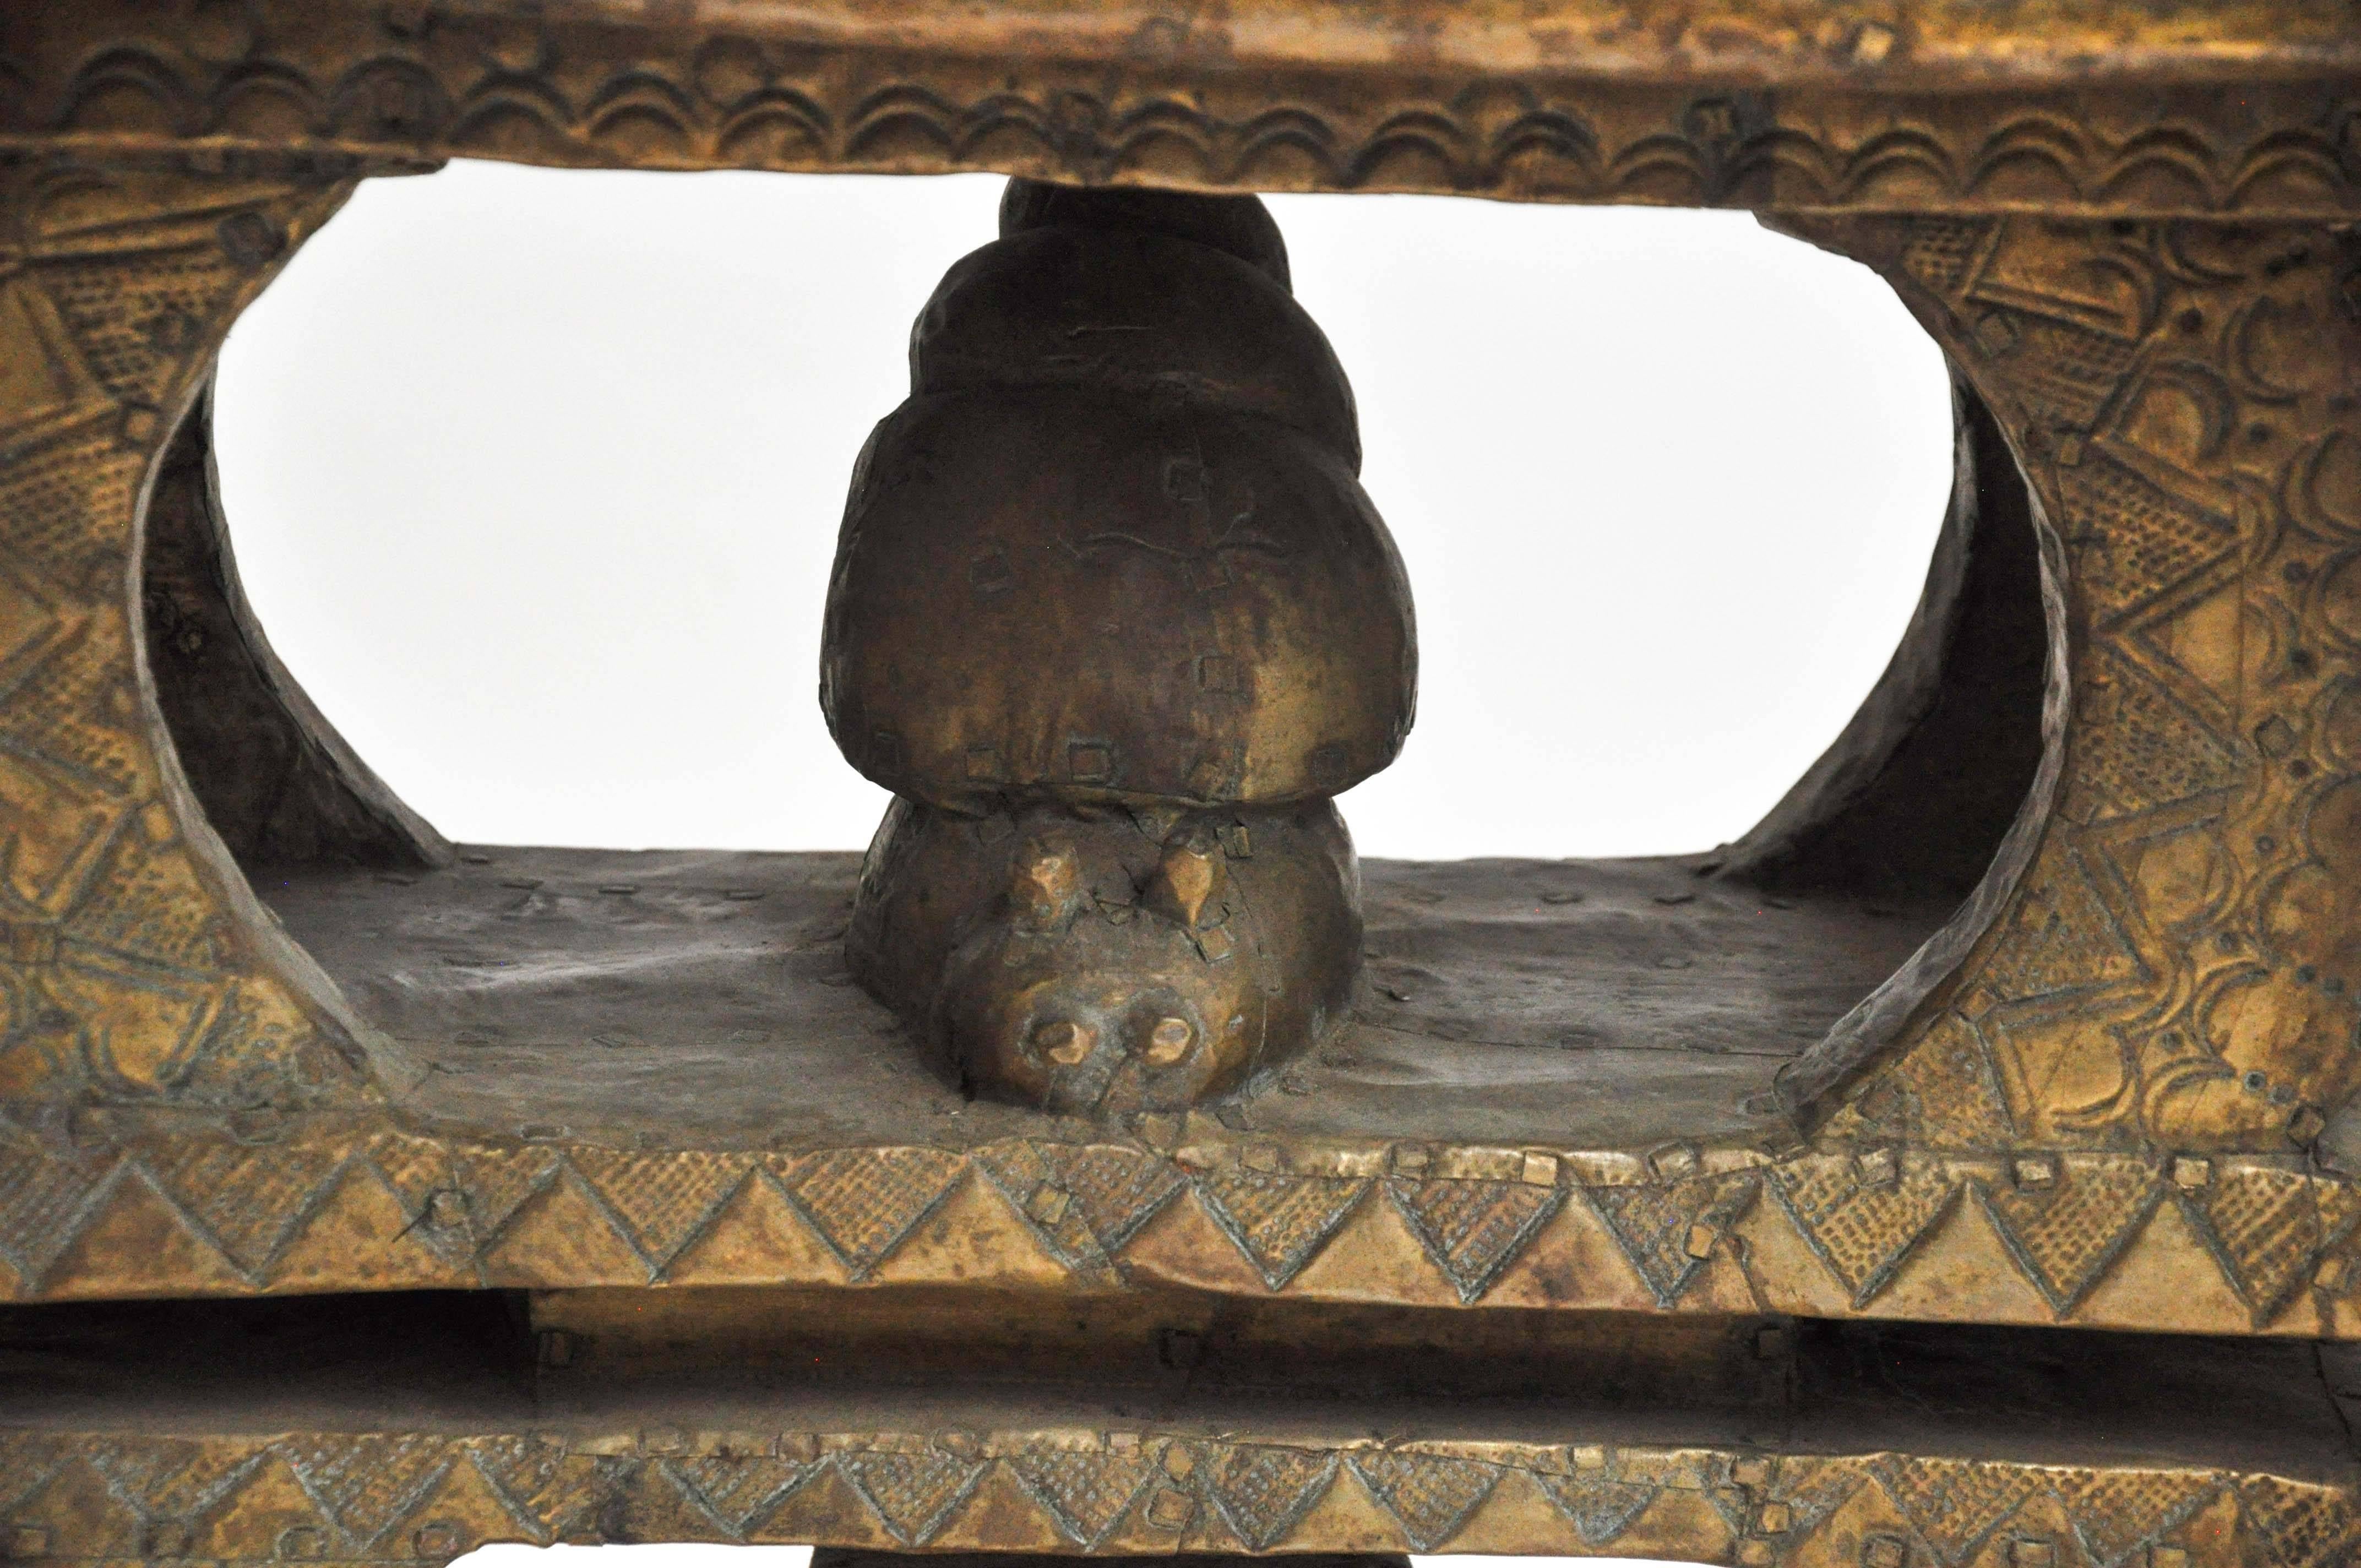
[0,1292,2361,1568]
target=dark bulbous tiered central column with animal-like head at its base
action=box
[822,179,1417,1112]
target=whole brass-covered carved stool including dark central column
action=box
[0,0,2361,1568]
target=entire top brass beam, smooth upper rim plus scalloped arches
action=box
[0,0,2361,217]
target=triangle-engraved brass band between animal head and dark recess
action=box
[0,1117,2361,1339]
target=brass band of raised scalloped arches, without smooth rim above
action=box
[0,0,2361,215]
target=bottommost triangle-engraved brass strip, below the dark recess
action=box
[0,1427,2361,1568]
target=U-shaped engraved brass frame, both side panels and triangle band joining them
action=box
[0,158,2361,1334]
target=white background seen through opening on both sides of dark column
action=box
[220,163,1950,857]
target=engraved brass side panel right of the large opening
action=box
[1780,215,2361,1152]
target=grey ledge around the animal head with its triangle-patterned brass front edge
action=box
[0,848,2361,1337]
